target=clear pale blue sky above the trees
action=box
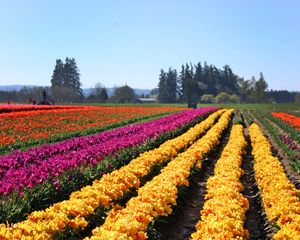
[0,0,300,91]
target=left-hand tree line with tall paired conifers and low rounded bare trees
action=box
[0,57,138,104]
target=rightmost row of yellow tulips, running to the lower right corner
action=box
[249,123,300,240]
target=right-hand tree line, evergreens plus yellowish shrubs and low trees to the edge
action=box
[158,62,299,103]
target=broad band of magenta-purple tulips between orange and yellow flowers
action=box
[0,108,216,195]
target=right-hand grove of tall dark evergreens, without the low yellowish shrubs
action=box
[159,62,268,105]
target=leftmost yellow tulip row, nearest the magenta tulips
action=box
[0,110,228,240]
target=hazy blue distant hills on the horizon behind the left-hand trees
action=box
[0,85,151,96]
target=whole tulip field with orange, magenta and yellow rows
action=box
[0,104,300,240]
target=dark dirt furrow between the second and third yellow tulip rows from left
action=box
[149,118,233,240]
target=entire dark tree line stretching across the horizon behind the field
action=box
[0,57,300,104]
